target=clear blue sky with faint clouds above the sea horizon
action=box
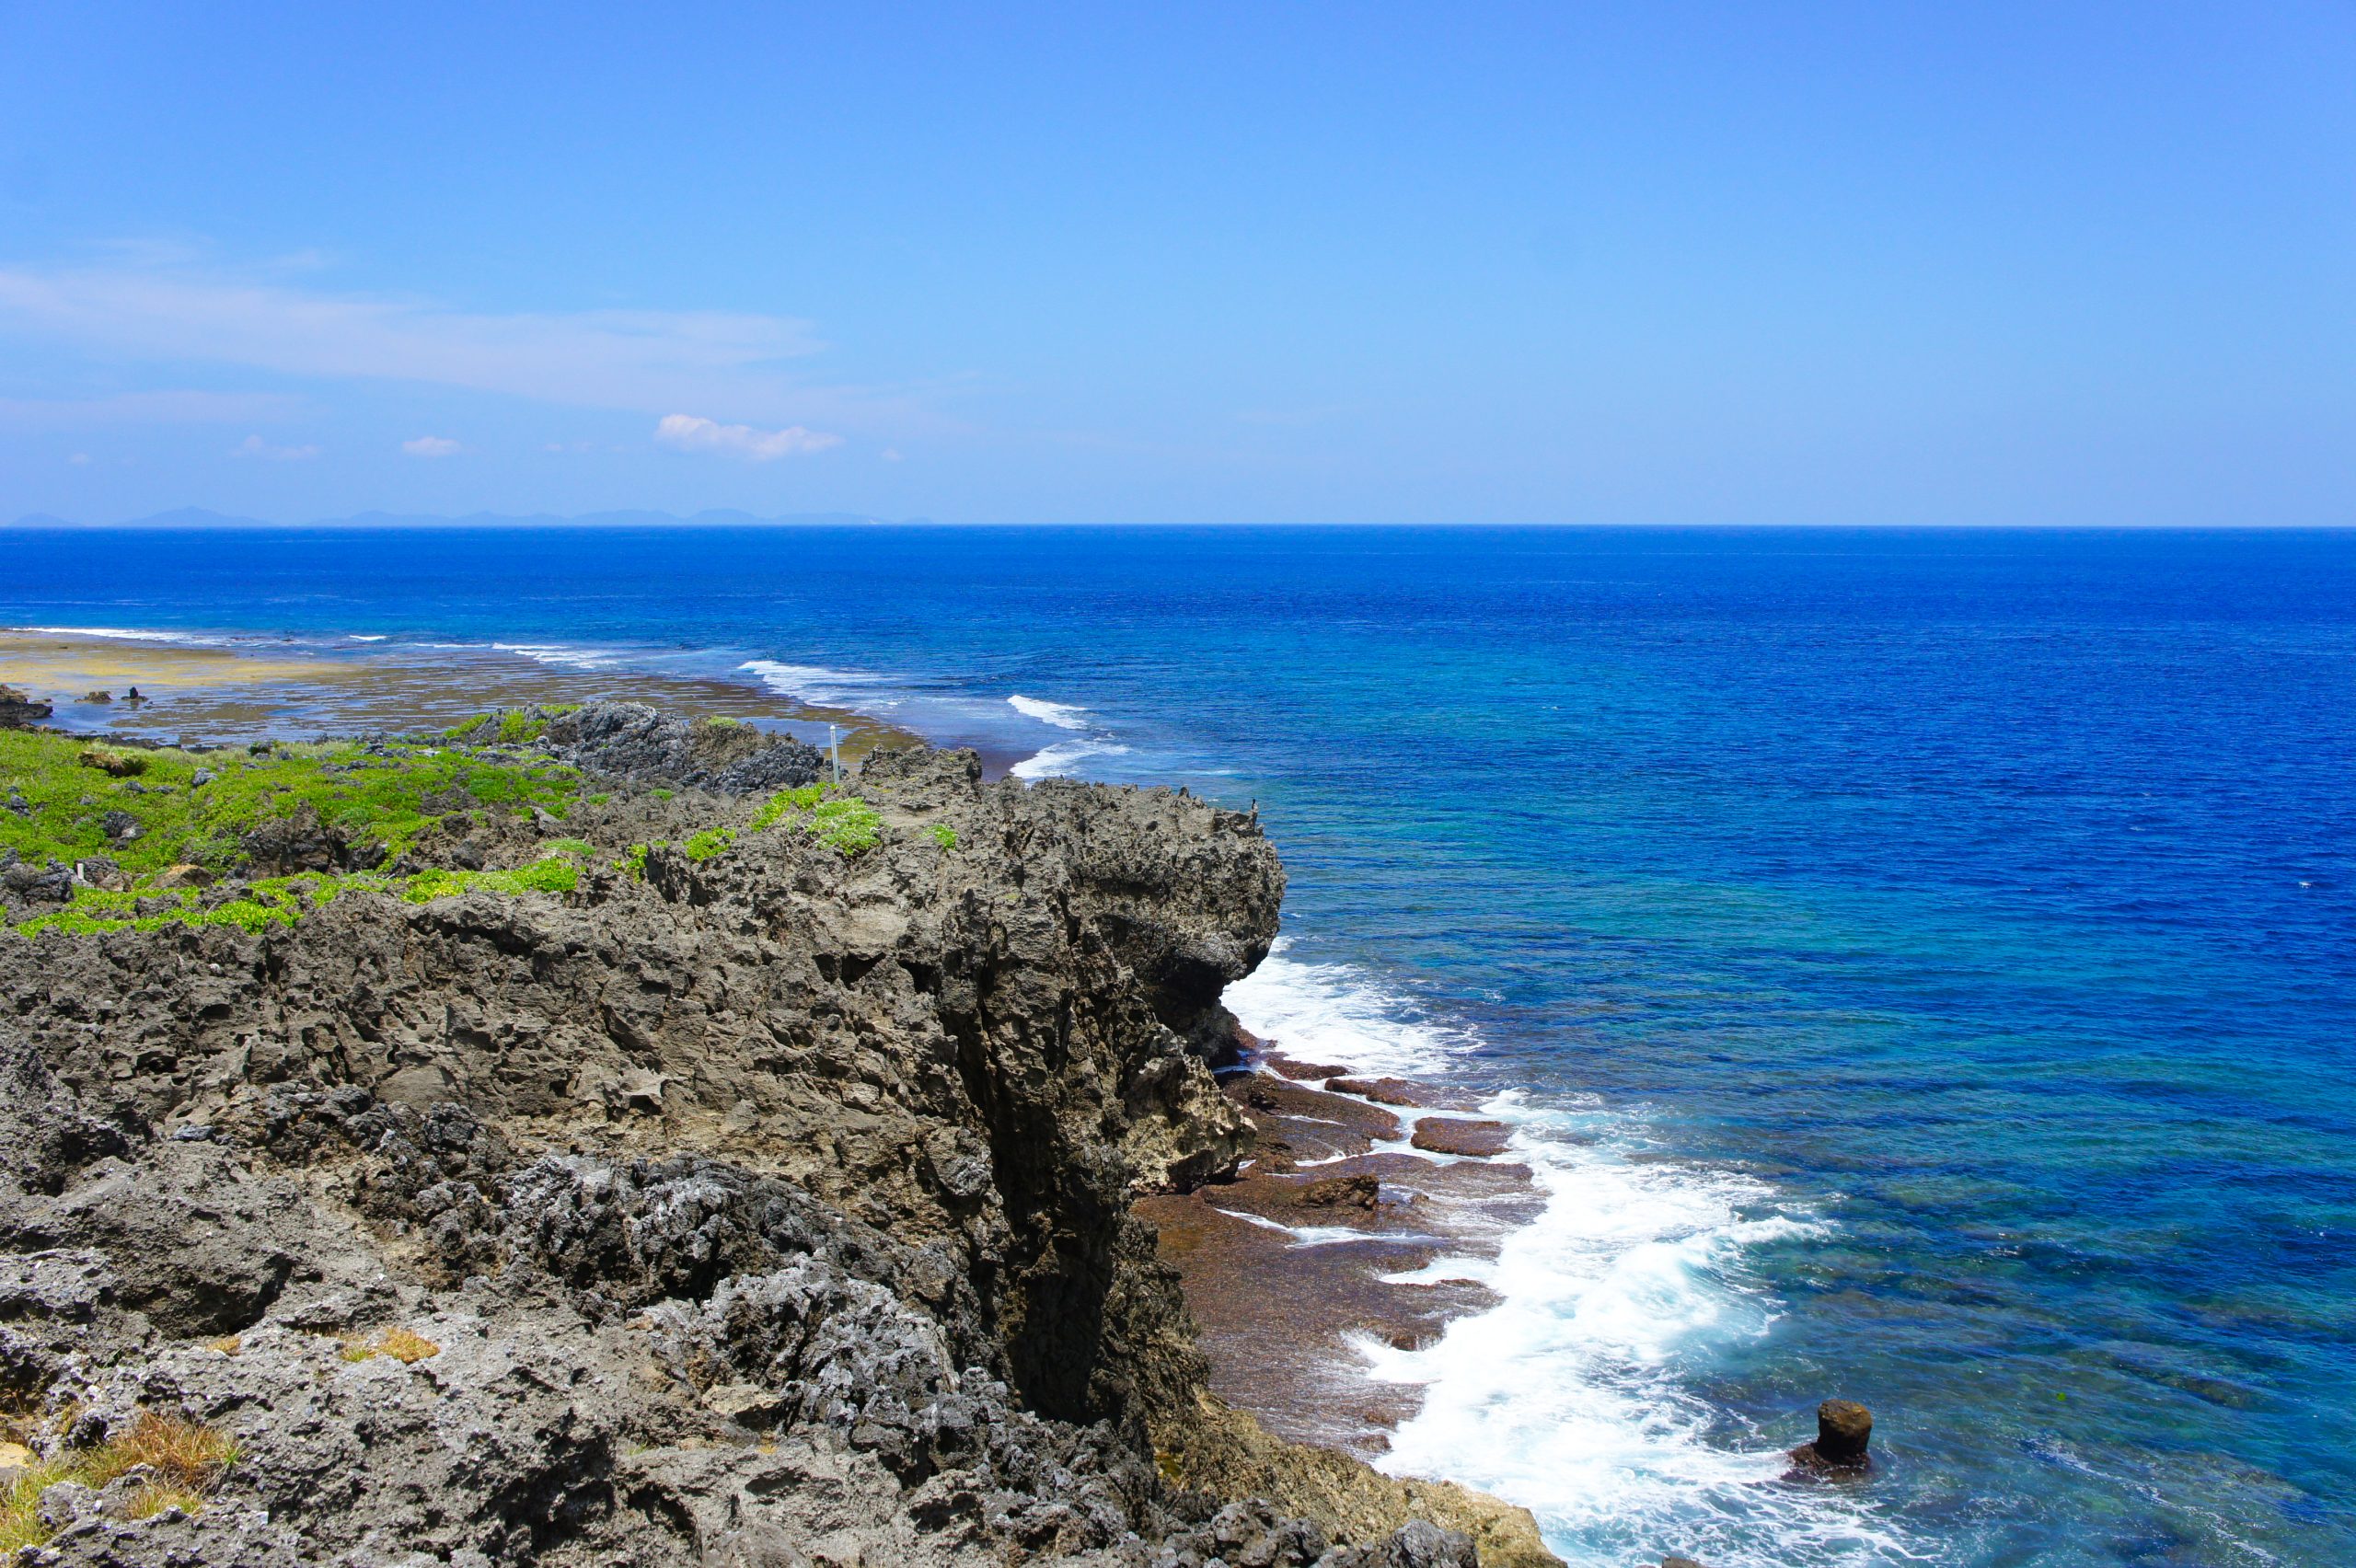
[0,0,2356,525]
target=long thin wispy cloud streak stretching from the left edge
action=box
[0,254,838,421]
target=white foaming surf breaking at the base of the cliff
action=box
[1225,941,1930,1568]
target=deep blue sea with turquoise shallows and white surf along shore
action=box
[0,527,2356,1568]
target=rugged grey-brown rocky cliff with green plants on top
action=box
[0,704,1553,1568]
